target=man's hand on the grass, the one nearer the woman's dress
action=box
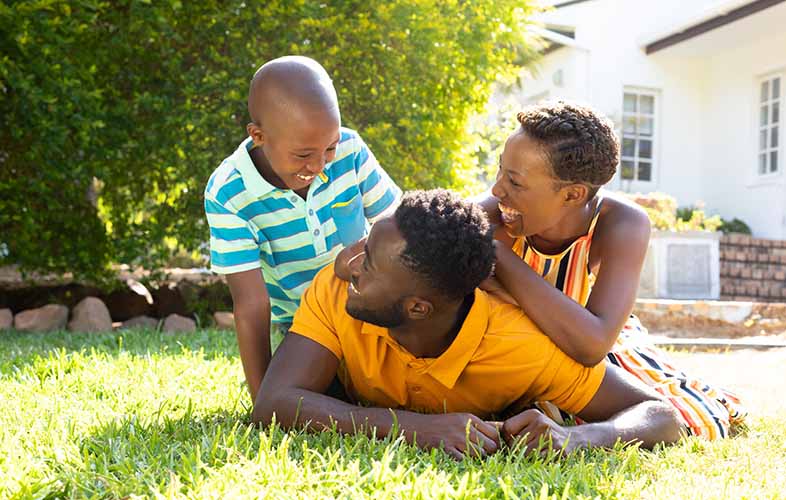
[501,409,582,454]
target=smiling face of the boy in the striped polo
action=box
[252,105,341,191]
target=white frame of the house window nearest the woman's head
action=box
[618,86,660,190]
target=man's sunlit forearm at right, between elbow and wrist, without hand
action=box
[570,401,681,449]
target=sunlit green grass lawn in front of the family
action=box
[0,331,786,500]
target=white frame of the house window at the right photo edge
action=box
[754,72,786,180]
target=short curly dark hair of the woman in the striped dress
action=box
[516,101,620,197]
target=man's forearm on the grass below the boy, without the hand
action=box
[253,388,424,443]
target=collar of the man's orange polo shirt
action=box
[361,289,489,389]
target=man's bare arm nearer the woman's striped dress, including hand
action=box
[502,364,681,451]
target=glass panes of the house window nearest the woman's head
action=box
[620,90,655,182]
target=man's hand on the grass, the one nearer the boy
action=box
[408,413,500,460]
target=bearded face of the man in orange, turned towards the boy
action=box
[346,218,417,328]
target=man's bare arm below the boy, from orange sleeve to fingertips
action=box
[253,332,498,459]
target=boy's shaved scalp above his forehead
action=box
[248,56,338,128]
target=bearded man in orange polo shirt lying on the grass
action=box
[253,190,680,458]
